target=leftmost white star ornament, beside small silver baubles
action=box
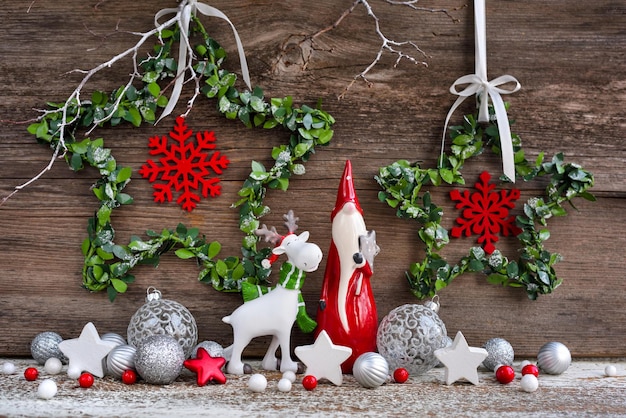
[59,322,117,379]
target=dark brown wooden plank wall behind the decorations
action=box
[0,0,626,357]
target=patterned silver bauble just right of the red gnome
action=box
[376,304,448,375]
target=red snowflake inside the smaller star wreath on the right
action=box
[450,171,522,254]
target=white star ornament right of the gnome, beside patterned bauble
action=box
[435,331,489,385]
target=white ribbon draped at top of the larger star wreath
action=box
[154,0,252,122]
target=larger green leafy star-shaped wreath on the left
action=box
[28,17,334,301]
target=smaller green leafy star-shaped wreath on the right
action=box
[375,110,595,300]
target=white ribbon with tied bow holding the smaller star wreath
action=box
[439,0,522,183]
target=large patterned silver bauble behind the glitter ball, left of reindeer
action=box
[127,289,198,358]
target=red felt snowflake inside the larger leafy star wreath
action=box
[139,116,230,212]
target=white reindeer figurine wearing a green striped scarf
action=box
[222,211,322,375]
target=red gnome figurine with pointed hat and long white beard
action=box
[316,160,379,373]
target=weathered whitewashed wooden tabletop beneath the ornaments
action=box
[0,358,626,418]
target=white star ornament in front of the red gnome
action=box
[294,331,352,386]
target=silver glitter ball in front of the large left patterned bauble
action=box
[135,335,185,385]
